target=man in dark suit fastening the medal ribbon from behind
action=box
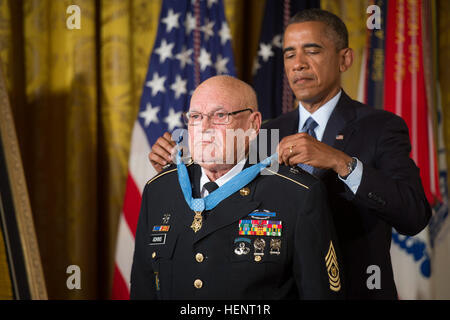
[149,9,431,299]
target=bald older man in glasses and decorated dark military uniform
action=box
[131,76,343,299]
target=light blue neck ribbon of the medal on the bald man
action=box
[176,139,278,212]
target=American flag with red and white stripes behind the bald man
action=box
[112,0,235,299]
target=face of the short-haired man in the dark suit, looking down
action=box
[283,21,346,103]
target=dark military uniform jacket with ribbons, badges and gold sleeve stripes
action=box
[131,164,345,300]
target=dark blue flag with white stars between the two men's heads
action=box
[252,0,320,120]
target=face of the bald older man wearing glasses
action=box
[188,86,257,169]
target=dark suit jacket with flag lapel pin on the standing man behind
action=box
[263,91,431,299]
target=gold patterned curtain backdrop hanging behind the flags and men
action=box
[0,0,450,299]
